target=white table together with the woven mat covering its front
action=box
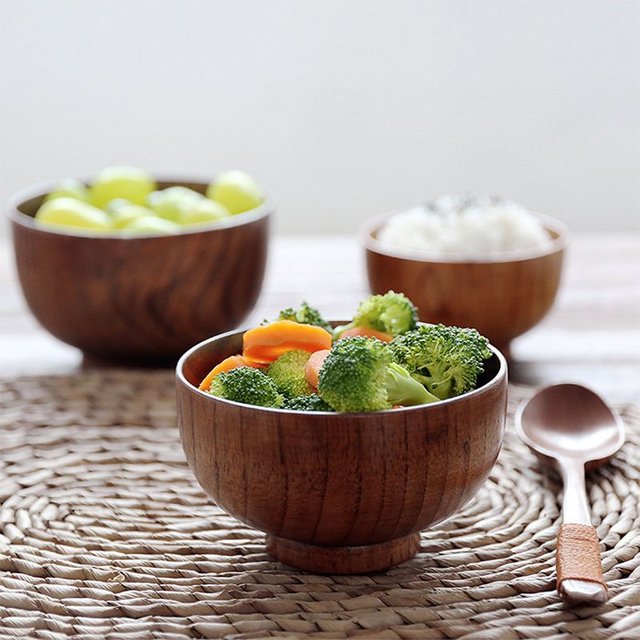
[0,234,640,640]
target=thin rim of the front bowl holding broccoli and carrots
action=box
[175,321,508,420]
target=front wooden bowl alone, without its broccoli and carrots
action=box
[176,332,507,573]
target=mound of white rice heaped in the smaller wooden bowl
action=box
[377,196,550,258]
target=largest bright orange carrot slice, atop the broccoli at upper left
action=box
[242,320,332,363]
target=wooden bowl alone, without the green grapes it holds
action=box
[9,180,273,364]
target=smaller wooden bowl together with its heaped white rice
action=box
[361,195,568,351]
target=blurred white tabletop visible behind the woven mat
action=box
[0,233,640,402]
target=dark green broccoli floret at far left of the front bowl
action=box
[209,367,284,408]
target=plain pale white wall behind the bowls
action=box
[0,0,640,233]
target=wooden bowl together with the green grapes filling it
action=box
[8,167,274,364]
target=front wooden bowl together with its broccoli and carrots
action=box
[176,292,507,574]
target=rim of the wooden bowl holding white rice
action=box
[358,209,569,265]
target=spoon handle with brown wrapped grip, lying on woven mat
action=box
[556,461,607,605]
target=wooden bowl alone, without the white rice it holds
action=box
[361,216,568,352]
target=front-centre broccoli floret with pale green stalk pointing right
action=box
[318,336,437,412]
